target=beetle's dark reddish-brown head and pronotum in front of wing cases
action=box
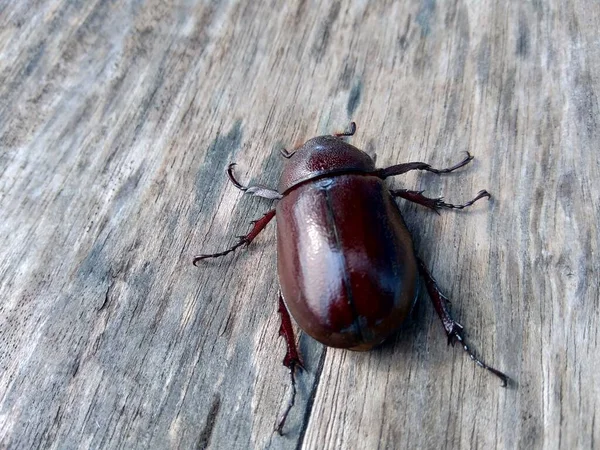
[278,135,375,194]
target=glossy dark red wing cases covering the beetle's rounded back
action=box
[277,174,417,350]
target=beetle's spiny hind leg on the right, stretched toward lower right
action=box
[417,258,508,387]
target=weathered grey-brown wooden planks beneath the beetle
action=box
[0,0,600,449]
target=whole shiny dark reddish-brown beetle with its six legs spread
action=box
[193,122,508,434]
